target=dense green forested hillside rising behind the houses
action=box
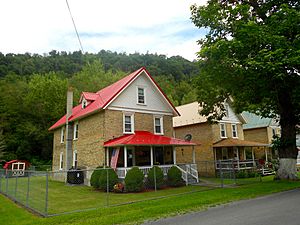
[0,50,199,163]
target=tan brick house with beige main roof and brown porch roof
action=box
[173,101,267,175]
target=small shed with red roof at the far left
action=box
[3,159,30,176]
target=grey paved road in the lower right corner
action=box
[144,189,300,225]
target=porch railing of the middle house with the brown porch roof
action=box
[216,160,256,170]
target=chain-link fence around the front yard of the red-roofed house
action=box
[0,161,268,216]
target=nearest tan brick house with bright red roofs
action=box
[49,68,198,183]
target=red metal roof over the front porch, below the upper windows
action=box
[104,131,196,147]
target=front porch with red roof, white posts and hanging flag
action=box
[104,131,199,183]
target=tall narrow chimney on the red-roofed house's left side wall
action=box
[65,88,73,170]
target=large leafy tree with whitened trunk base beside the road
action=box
[191,0,300,179]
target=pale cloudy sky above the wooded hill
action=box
[0,0,206,60]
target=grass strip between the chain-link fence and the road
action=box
[0,177,300,225]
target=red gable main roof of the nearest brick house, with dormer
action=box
[49,67,179,130]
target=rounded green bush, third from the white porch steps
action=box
[125,167,144,192]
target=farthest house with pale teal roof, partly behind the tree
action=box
[242,112,281,162]
